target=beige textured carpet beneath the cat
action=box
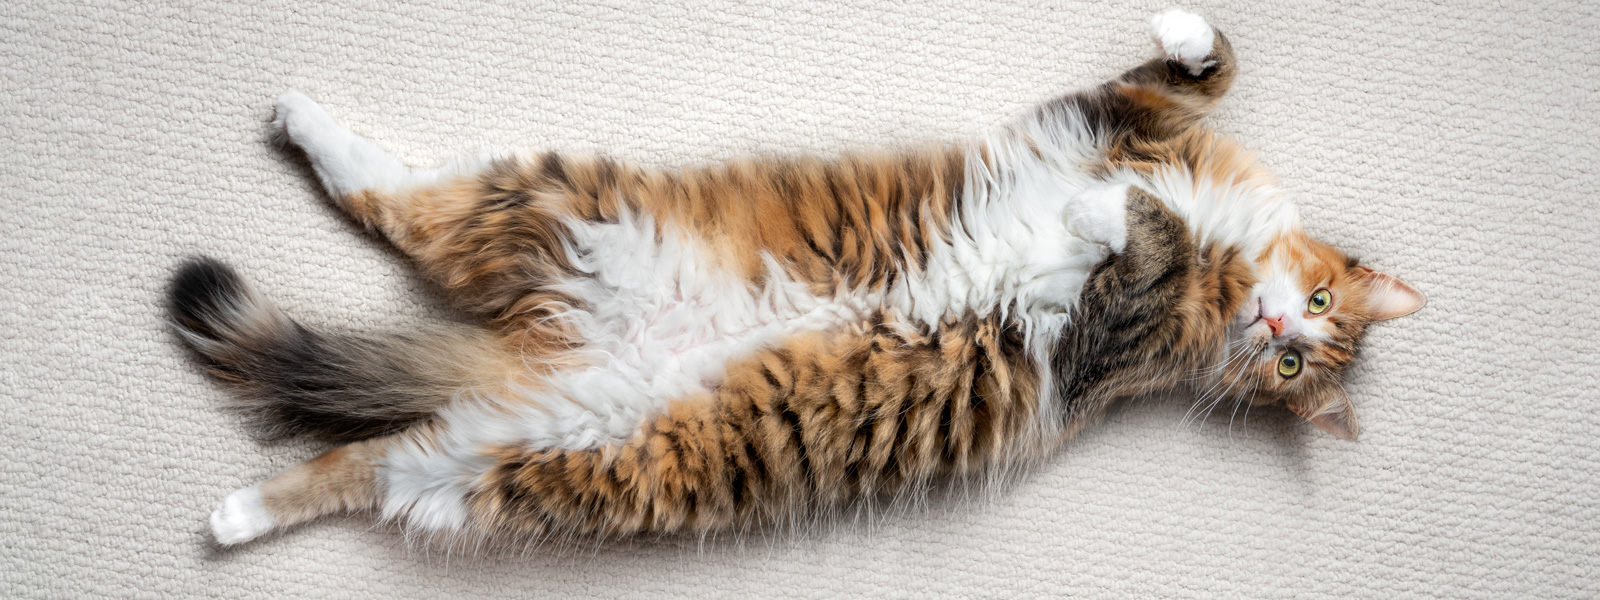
[0,0,1600,600]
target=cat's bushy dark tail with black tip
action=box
[168,259,510,442]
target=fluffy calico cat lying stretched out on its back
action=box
[170,11,1424,544]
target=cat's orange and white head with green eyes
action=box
[1219,232,1426,440]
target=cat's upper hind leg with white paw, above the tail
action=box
[274,91,598,354]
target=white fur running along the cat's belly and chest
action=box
[378,129,1106,531]
